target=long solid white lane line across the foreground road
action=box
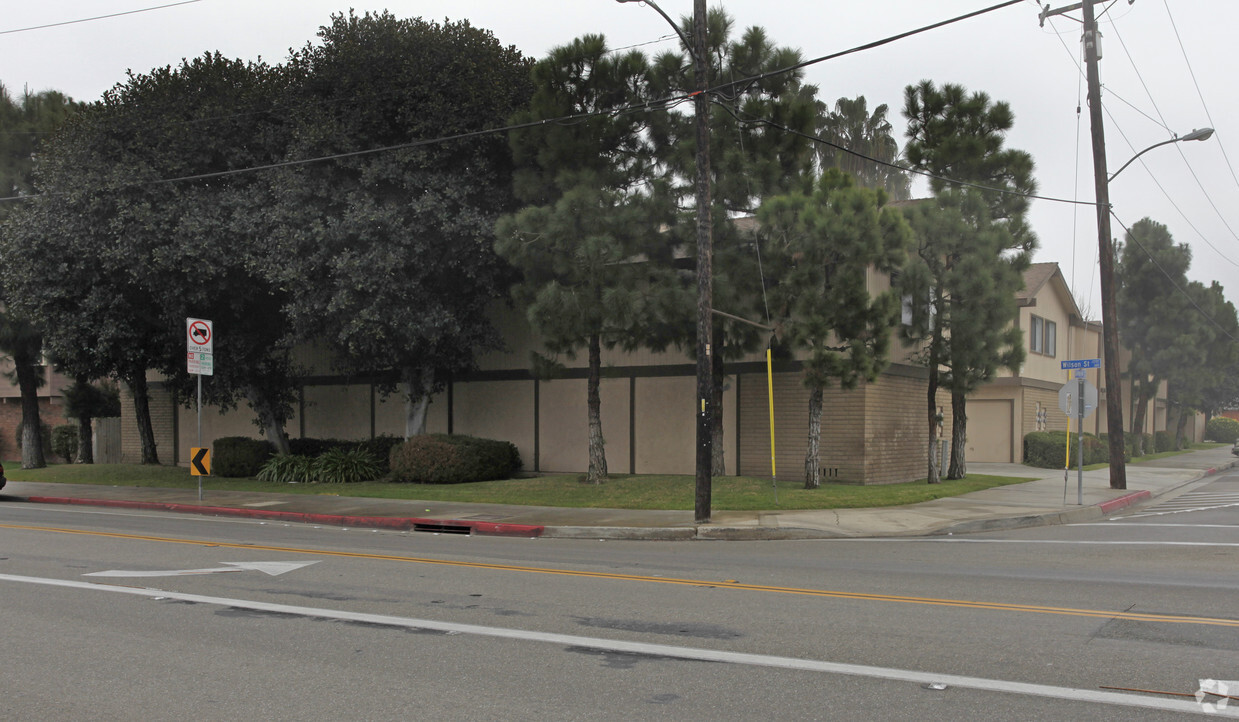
[0,575,1219,718]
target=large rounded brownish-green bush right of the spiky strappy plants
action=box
[390,433,520,484]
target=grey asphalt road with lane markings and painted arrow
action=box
[0,476,1239,720]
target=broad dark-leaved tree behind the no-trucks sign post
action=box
[4,53,291,463]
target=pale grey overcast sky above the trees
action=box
[0,0,1239,318]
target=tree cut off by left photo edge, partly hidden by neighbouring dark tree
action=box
[0,84,81,468]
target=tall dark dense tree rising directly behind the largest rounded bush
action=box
[268,12,530,436]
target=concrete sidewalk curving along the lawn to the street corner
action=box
[0,446,1239,540]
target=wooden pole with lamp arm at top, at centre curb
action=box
[616,0,714,524]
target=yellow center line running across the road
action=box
[9,524,1239,628]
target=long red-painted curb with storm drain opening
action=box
[26,497,545,536]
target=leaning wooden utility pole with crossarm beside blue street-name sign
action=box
[1041,0,1127,489]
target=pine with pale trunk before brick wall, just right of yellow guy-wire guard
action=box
[757,168,912,489]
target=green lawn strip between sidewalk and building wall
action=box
[7,463,1030,511]
